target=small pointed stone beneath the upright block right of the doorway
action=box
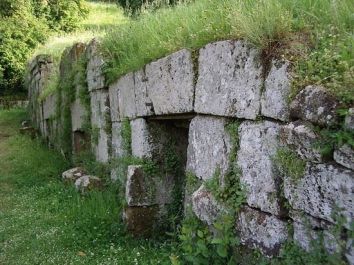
[192,185,224,225]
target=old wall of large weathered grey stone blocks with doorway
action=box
[29,40,354,264]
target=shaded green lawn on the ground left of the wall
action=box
[0,110,170,265]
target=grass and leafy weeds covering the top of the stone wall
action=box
[103,0,354,104]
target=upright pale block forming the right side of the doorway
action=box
[187,116,231,180]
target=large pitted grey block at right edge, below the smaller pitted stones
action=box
[284,164,354,227]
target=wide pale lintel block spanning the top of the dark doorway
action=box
[145,50,194,115]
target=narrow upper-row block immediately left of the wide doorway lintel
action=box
[134,69,153,117]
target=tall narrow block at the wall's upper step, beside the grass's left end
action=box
[86,39,105,91]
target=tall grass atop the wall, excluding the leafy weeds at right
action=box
[103,0,354,82]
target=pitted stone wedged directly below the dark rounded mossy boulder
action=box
[280,121,323,162]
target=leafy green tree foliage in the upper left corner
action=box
[0,0,86,94]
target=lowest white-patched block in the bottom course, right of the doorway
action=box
[236,207,288,256]
